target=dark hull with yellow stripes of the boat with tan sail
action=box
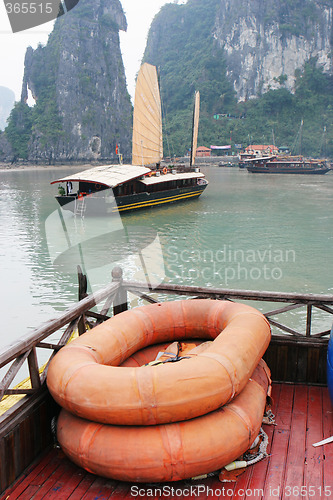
[56,184,207,215]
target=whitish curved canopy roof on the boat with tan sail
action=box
[51,165,151,188]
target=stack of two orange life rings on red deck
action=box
[47,299,270,482]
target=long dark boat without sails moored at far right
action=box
[244,155,331,175]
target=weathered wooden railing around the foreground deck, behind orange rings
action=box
[0,268,333,401]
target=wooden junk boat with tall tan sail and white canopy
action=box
[51,63,208,215]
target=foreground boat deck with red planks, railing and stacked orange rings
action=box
[0,269,333,500]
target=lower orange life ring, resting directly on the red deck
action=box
[57,360,270,482]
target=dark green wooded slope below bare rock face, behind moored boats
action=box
[209,59,333,157]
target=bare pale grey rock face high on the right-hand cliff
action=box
[212,0,333,100]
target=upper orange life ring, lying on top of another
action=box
[47,299,270,425]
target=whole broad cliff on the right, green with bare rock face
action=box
[144,0,333,155]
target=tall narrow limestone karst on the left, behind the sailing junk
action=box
[16,0,132,163]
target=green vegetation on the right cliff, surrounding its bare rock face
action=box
[144,0,333,157]
